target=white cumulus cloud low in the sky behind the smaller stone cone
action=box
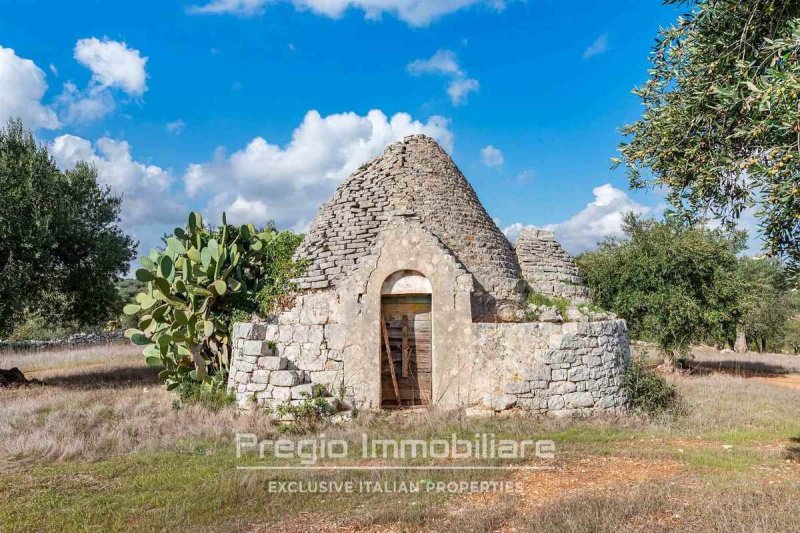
[503,183,652,254]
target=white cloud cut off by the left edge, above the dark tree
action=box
[0,46,60,129]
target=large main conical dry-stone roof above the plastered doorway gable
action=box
[296,135,524,314]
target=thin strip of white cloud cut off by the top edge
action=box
[189,0,505,26]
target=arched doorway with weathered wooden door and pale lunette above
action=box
[380,270,432,409]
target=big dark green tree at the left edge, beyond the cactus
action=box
[0,121,135,336]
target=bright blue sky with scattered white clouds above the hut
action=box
[0,0,704,258]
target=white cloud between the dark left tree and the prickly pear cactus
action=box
[50,135,187,227]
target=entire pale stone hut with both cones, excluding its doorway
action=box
[228,136,630,416]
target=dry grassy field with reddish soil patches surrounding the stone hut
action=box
[0,346,800,532]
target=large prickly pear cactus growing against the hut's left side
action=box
[123,213,286,391]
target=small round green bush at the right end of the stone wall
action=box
[622,357,680,416]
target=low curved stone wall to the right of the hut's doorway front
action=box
[474,320,630,416]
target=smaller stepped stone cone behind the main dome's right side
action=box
[515,228,589,303]
